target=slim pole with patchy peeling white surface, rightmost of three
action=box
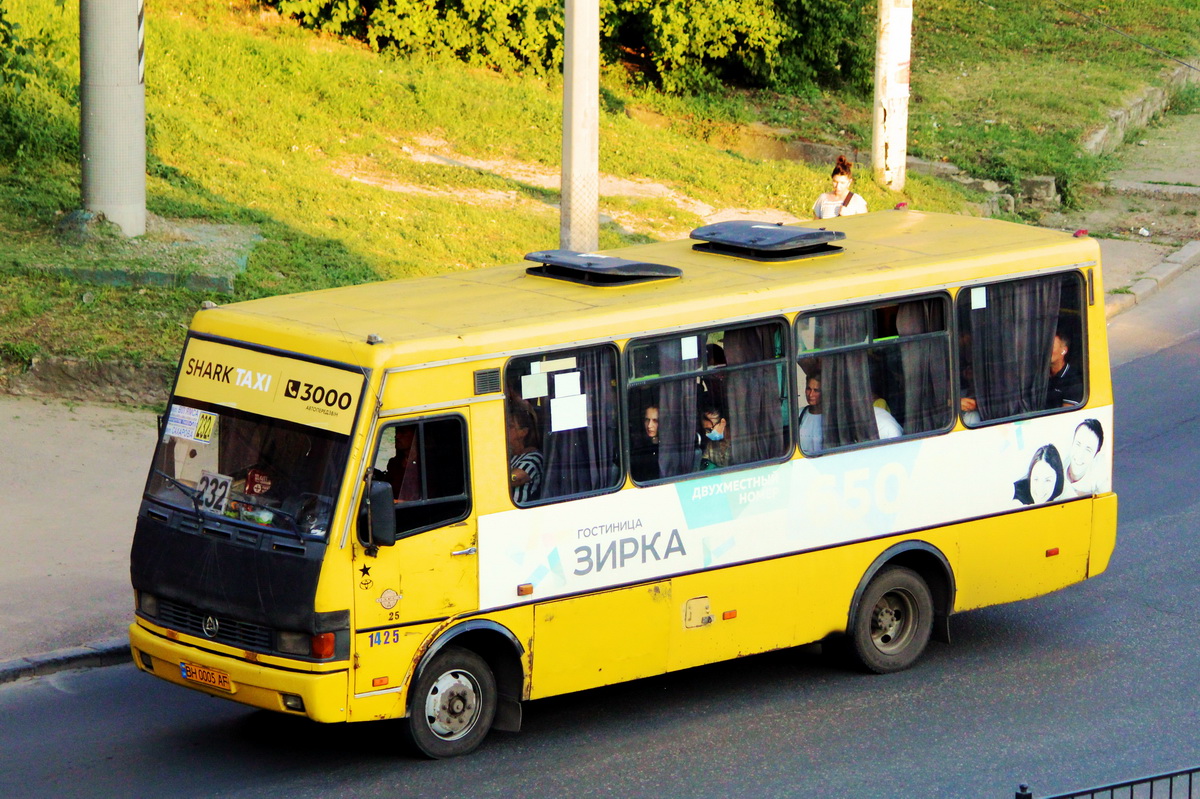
[871,0,912,192]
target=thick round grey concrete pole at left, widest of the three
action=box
[79,0,146,236]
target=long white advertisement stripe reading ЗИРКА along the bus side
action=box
[479,407,1112,608]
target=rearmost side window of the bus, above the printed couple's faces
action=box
[958,272,1087,426]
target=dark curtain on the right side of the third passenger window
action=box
[896,299,950,433]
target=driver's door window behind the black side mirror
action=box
[364,416,470,536]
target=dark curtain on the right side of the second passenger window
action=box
[725,325,784,463]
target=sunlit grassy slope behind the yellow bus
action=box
[0,0,1198,368]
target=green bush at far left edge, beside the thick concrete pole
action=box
[0,7,79,162]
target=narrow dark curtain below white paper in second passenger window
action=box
[658,335,703,477]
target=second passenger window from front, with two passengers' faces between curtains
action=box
[626,320,792,482]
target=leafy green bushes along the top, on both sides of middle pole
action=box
[272,0,875,92]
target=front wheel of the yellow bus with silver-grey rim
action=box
[408,647,497,759]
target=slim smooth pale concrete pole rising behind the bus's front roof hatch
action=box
[558,0,600,252]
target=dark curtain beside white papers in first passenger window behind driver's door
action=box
[541,348,619,499]
